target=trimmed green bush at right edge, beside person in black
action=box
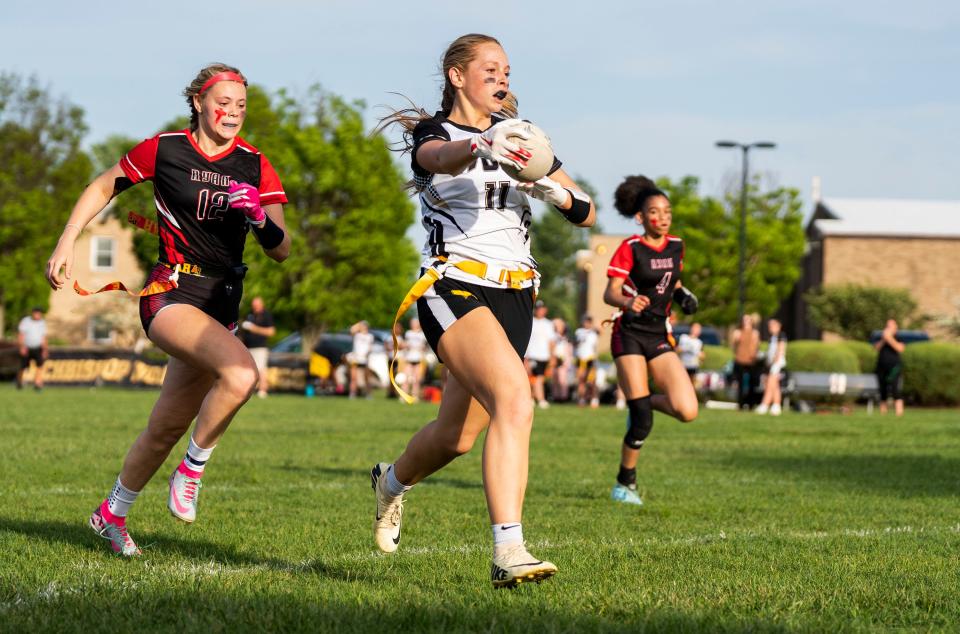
[902,342,960,405]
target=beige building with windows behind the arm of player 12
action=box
[46,206,144,347]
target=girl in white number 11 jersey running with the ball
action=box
[371,34,596,587]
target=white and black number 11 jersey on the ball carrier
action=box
[412,112,561,288]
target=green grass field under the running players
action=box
[0,386,960,632]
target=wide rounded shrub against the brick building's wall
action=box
[804,284,925,341]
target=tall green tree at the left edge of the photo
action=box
[0,73,91,333]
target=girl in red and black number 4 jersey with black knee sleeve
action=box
[603,176,697,505]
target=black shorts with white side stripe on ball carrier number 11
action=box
[417,277,533,363]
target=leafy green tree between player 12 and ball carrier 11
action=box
[235,86,417,340]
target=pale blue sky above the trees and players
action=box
[0,0,960,233]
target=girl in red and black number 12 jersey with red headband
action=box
[47,64,290,556]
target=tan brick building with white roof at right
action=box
[781,198,960,338]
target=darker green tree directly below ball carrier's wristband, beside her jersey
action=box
[530,177,600,324]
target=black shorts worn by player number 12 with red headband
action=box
[140,264,243,336]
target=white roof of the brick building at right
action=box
[810,198,960,238]
